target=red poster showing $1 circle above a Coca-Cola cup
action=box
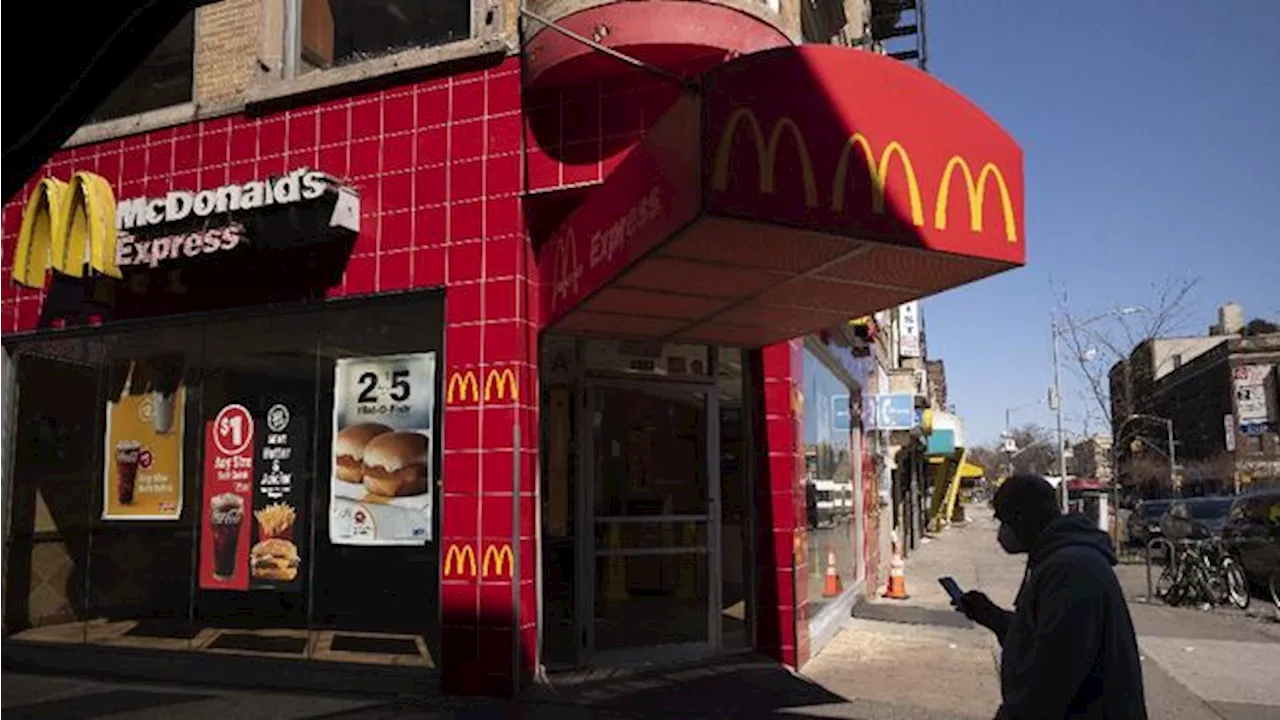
[200,405,257,591]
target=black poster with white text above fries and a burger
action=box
[248,396,311,591]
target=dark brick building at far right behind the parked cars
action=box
[1111,304,1280,493]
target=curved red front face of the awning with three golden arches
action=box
[705,46,1025,264]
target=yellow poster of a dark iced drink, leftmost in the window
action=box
[102,360,187,520]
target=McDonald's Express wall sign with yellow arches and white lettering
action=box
[13,168,360,288]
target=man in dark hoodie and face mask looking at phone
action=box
[957,475,1147,720]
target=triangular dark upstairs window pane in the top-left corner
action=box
[87,10,196,123]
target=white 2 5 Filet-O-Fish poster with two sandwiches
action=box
[329,352,436,546]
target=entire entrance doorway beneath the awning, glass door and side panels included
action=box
[539,336,755,670]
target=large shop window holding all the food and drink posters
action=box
[5,296,442,667]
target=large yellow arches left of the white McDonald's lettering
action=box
[13,172,122,290]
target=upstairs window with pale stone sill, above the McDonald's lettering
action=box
[296,0,471,72]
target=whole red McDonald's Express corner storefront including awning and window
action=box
[0,46,1024,694]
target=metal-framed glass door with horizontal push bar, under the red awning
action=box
[579,380,721,659]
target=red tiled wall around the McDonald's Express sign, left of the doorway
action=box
[0,58,538,694]
